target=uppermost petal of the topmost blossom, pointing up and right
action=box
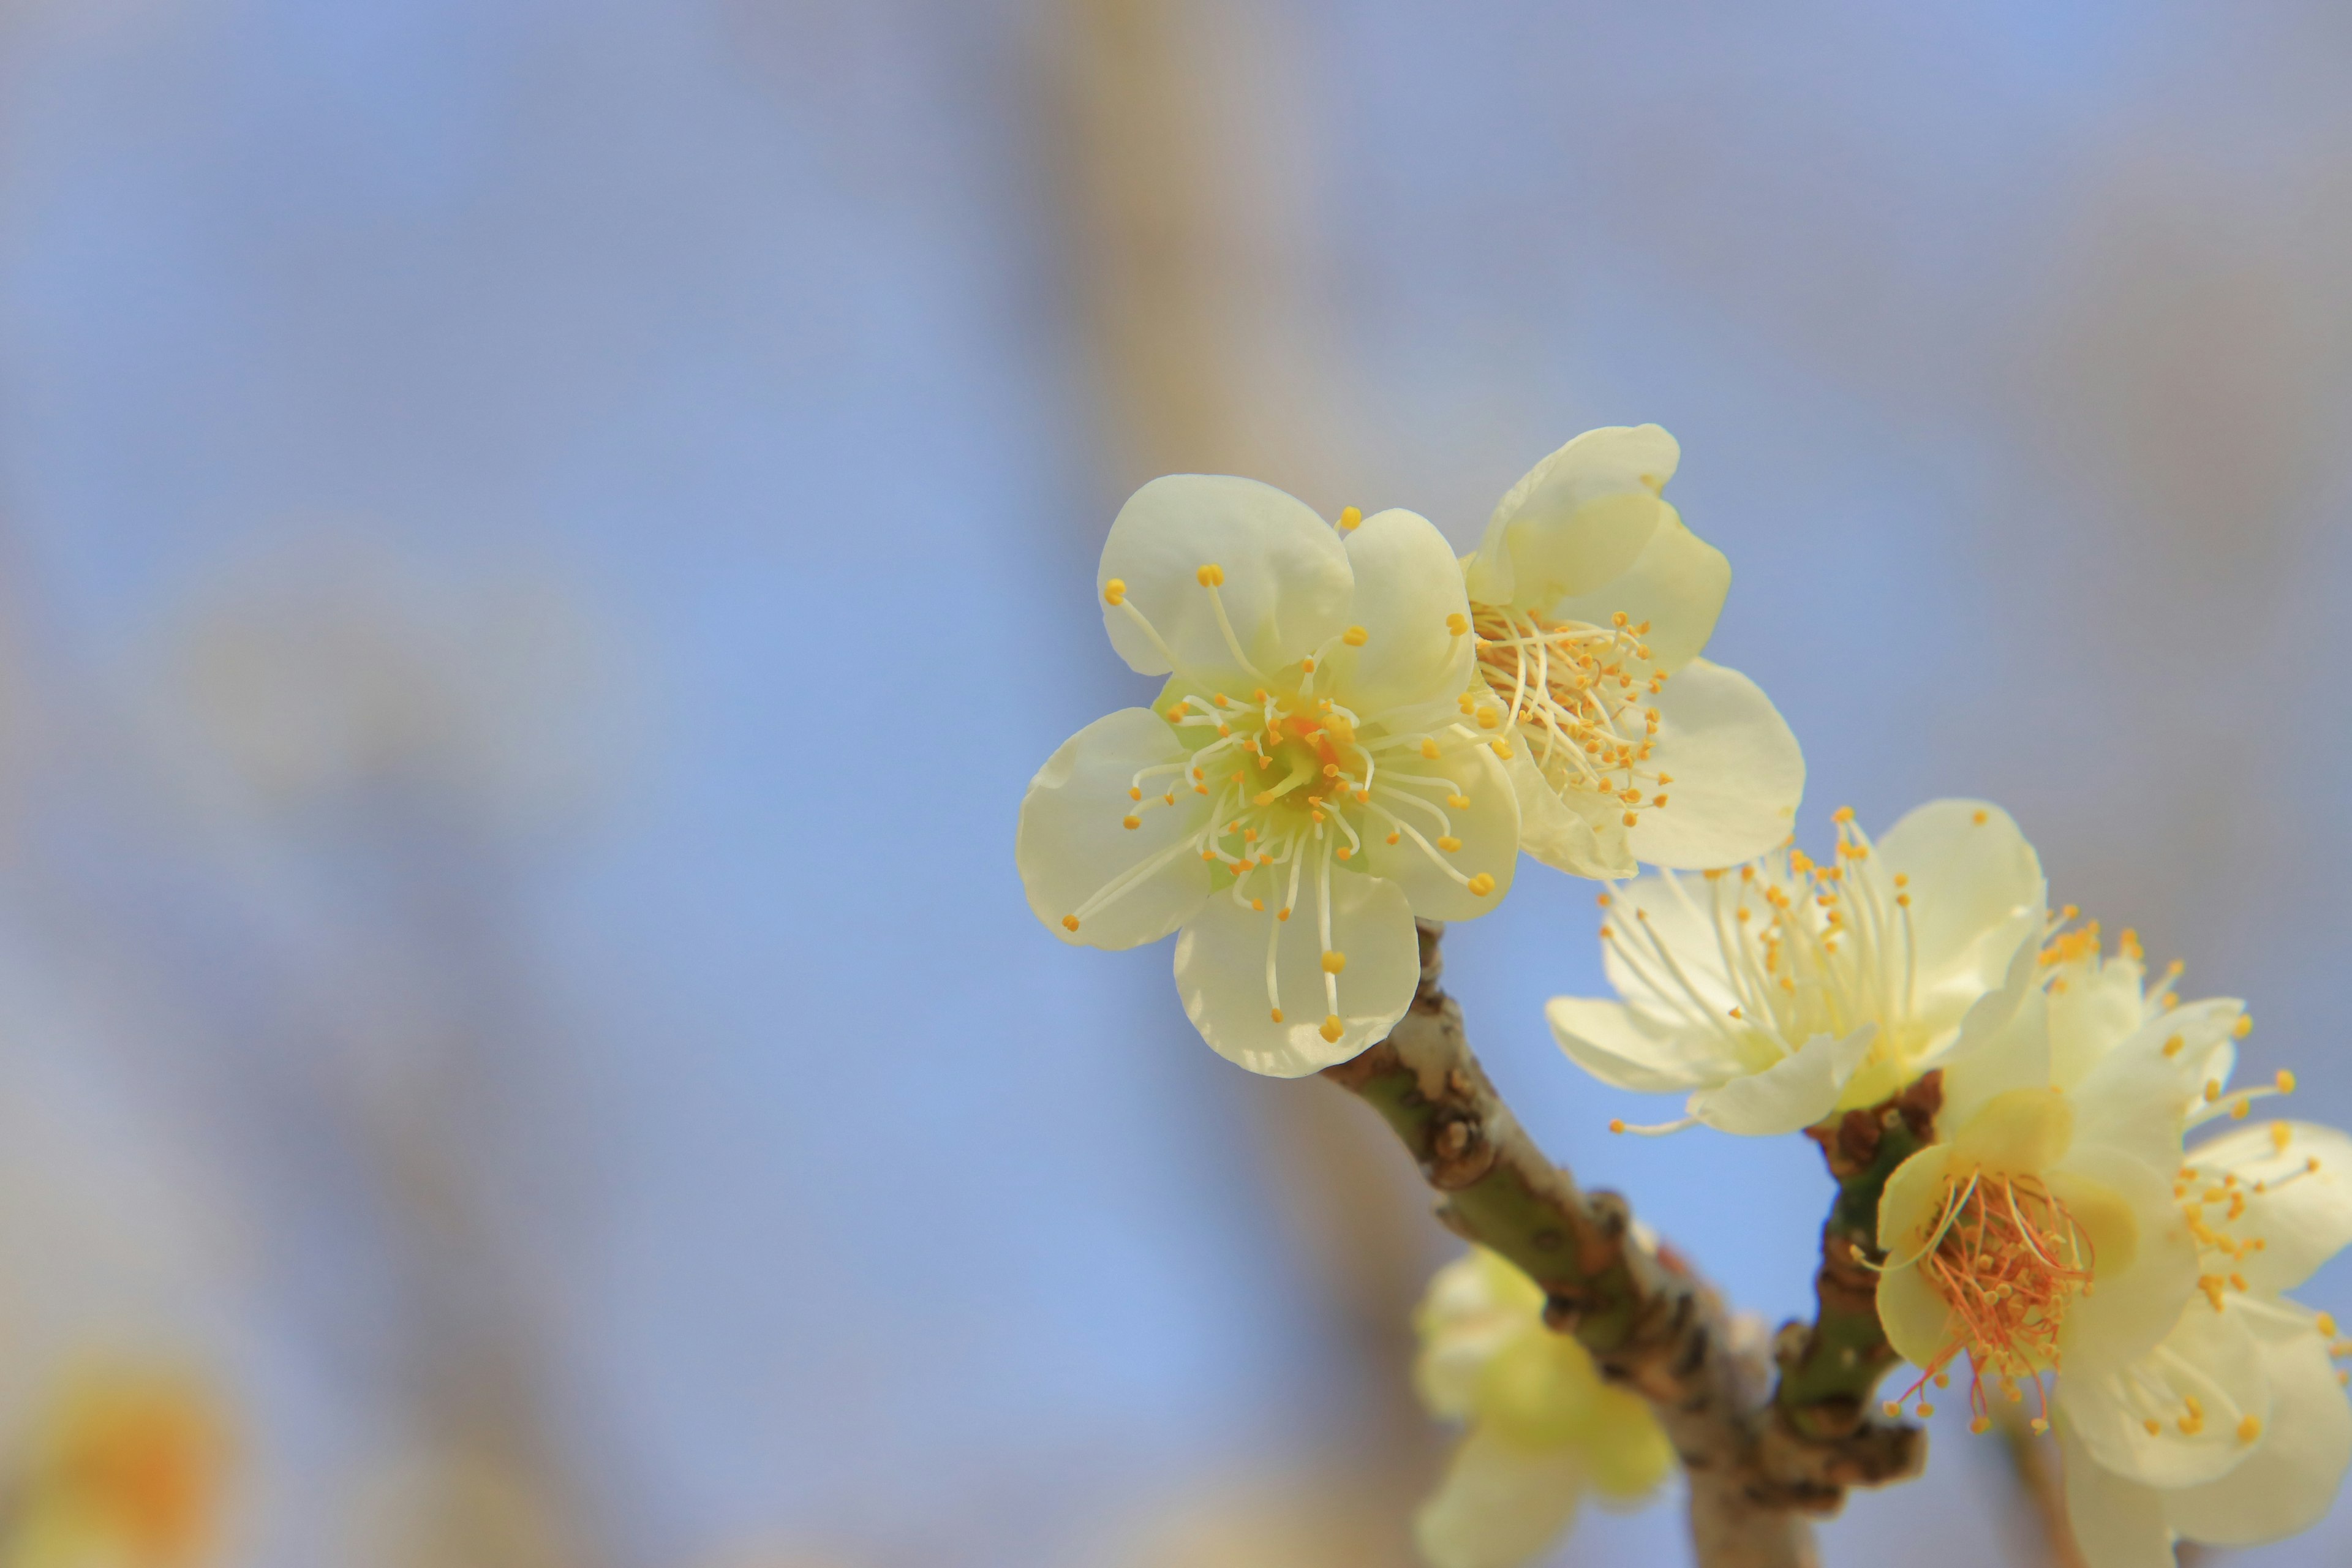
[1465,426,1682,609]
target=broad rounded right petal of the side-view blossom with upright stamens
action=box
[1872,804,2044,999]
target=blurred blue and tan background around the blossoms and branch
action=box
[0,0,2352,1568]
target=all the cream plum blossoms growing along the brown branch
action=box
[1019,426,2352,1568]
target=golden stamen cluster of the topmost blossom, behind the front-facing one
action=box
[1463,604,1672,827]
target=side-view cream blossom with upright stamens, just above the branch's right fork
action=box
[1545,799,2044,1136]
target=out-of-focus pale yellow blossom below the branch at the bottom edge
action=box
[1414,1248,1675,1568]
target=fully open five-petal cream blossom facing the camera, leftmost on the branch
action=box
[1016,475,1520,1077]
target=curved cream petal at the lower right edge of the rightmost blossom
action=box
[2164,1329,2352,1547]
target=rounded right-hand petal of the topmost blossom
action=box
[1627,658,1804,870]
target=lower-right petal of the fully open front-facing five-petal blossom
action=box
[1357,742,1520,922]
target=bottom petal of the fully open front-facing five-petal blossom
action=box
[1176,872,1420,1079]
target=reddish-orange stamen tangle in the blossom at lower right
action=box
[1905,1170,2094,1431]
